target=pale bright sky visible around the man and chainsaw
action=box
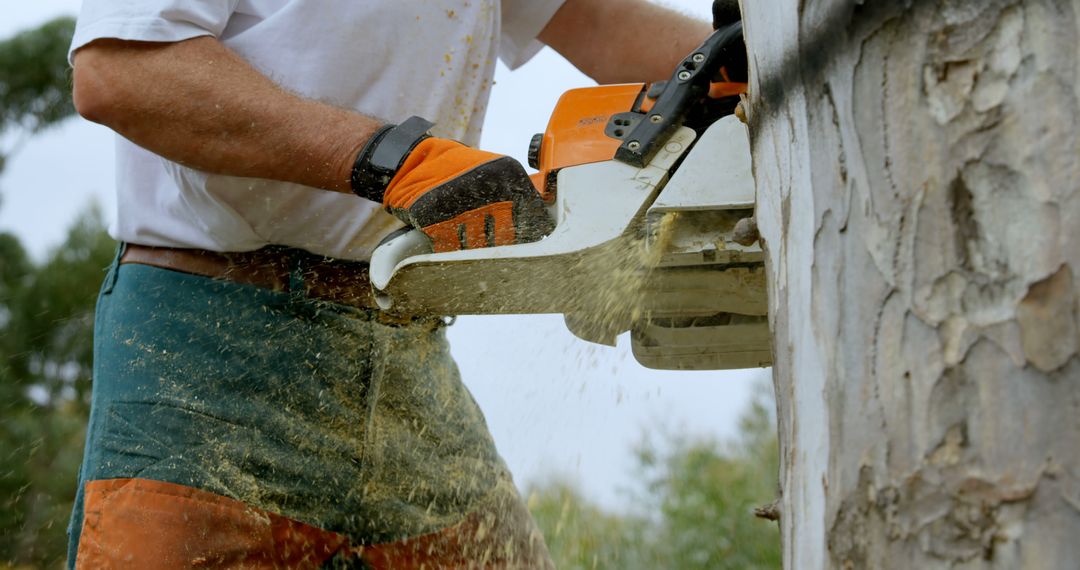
[0,0,768,506]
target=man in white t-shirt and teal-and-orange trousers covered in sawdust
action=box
[63,0,730,568]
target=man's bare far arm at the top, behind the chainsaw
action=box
[539,0,712,83]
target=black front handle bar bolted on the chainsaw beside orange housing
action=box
[608,22,745,168]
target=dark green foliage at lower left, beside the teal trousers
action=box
[0,208,116,568]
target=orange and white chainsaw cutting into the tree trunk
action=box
[370,29,772,370]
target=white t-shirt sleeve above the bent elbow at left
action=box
[68,0,240,62]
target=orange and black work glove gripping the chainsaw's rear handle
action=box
[351,117,554,252]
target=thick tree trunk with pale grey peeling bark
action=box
[743,0,1080,570]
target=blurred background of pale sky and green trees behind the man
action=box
[0,0,780,569]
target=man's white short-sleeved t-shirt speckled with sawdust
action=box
[71,0,564,260]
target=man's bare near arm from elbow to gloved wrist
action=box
[75,37,379,192]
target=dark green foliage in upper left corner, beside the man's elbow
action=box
[0,17,75,171]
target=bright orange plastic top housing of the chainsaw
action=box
[529,82,746,204]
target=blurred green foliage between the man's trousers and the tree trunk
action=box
[529,382,781,570]
